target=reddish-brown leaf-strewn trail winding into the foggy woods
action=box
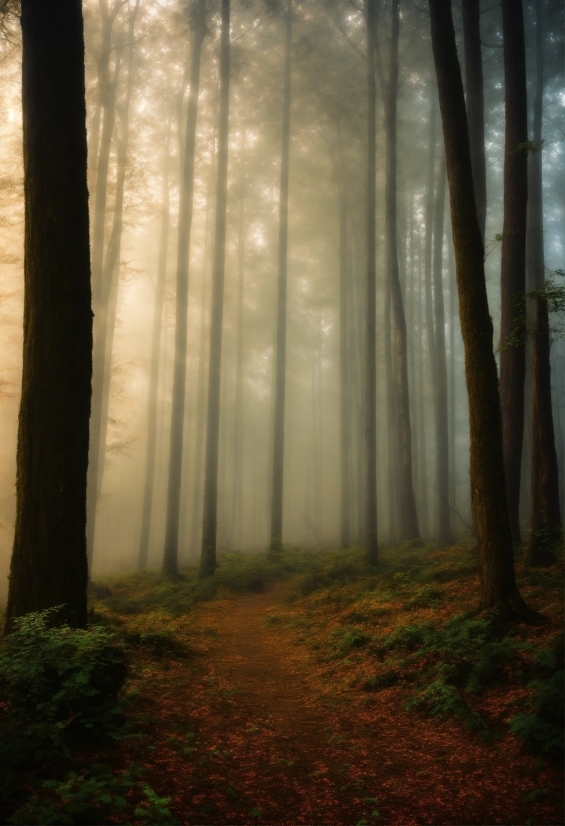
[127,583,559,826]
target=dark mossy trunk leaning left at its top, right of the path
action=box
[430,0,526,614]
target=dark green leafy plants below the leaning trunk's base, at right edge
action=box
[376,612,564,756]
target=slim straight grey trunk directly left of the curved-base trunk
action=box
[365,0,378,565]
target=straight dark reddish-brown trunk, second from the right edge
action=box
[500,0,528,544]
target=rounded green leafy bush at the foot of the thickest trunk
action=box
[0,609,127,816]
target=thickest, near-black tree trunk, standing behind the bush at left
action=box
[6,0,92,630]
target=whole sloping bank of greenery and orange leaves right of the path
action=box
[267,541,563,758]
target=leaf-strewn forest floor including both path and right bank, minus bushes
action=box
[89,547,563,826]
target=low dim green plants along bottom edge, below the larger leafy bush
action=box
[9,764,176,826]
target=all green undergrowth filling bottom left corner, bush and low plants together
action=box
[0,609,173,824]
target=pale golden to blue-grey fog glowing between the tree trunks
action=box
[0,0,565,599]
